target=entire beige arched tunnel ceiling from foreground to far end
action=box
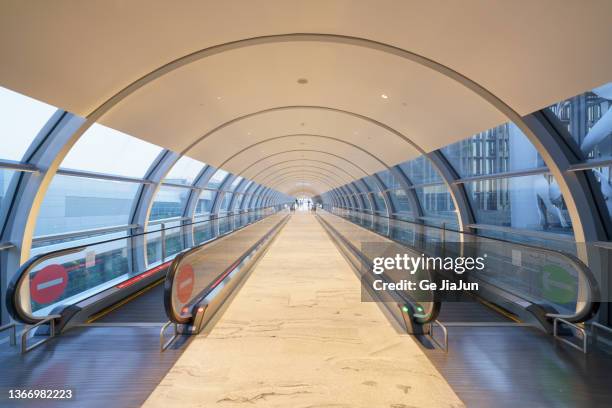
[0,0,612,197]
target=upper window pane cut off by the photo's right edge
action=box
[549,82,612,159]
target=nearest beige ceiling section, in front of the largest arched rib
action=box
[0,0,612,115]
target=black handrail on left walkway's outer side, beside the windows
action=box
[6,206,274,325]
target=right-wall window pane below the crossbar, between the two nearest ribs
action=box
[465,174,572,234]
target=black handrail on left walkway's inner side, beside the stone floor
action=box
[161,211,291,326]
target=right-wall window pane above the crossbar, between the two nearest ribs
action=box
[441,123,545,177]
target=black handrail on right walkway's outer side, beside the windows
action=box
[328,210,600,323]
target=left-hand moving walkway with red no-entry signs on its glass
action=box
[7,208,286,353]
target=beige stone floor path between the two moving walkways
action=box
[144,212,463,408]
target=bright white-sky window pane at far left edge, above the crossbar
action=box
[0,87,57,161]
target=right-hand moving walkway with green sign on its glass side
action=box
[318,210,600,353]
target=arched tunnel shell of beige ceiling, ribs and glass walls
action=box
[0,0,612,408]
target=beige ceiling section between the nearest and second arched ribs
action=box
[102,42,504,156]
